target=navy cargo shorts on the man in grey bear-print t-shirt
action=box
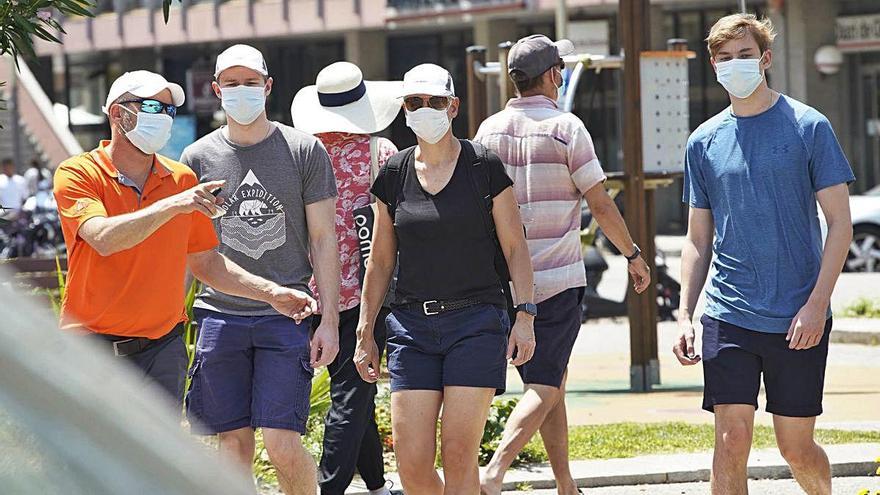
[186,309,314,434]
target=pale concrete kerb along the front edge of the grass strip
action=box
[346,443,880,495]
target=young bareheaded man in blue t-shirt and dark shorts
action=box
[673,14,855,495]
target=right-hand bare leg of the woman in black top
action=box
[440,387,495,495]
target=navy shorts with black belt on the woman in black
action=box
[385,304,510,394]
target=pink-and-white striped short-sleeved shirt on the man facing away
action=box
[474,96,605,303]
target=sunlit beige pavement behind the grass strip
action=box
[507,319,880,431]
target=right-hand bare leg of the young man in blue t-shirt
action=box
[773,415,831,495]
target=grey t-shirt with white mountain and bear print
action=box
[180,123,336,316]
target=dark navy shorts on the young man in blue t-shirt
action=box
[700,315,831,418]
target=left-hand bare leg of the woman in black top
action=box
[391,390,443,495]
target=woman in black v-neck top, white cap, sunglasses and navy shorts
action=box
[354,64,535,495]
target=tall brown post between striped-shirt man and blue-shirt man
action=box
[620,0,657,392]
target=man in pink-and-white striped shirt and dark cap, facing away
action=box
[475,35,650,495]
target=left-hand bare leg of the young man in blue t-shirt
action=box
[712,404,755,495]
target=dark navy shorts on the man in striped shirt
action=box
[517,287,584,388]
